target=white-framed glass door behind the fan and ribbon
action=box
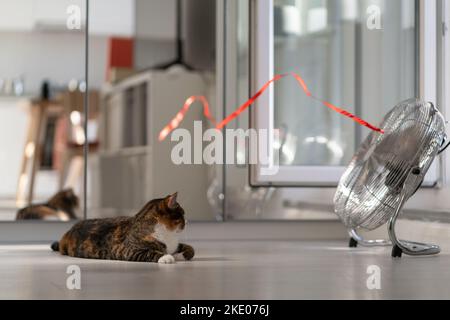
[250,0,438,186]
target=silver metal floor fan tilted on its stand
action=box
[334,99,448,257]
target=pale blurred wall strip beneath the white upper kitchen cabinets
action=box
[0,32,107,95]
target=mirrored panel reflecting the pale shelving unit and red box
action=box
[88,0,221,220]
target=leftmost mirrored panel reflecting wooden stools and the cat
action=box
[0,0,86,221]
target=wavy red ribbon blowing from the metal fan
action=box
[159,72,384,141]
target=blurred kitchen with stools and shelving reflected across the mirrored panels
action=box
[0,0,216,220]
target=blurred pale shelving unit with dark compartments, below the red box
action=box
[90,71,211,219]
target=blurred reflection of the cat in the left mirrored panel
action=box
[16,188,79,221]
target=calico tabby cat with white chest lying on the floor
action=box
[51,193,194,263]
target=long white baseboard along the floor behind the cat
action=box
[0,219,450,244]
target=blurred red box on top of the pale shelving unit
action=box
[106,37,134,80]
